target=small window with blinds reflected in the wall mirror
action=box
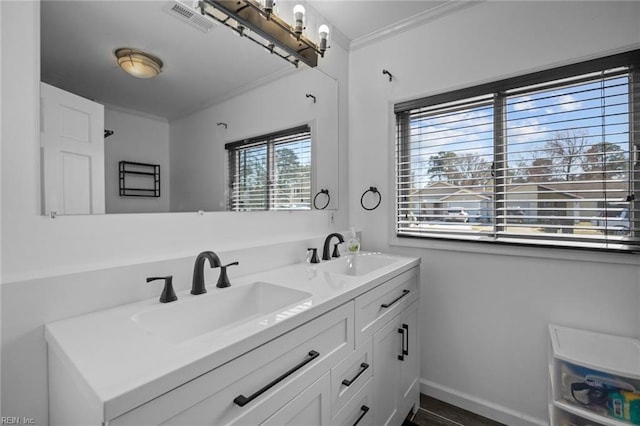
[225,125,311,211]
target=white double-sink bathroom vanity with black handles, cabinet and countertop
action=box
[45,253,420,425]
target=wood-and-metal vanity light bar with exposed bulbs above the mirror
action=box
[198,0,329,68]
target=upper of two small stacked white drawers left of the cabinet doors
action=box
[331,339,373,415]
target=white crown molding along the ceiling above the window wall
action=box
[350,0,487,50]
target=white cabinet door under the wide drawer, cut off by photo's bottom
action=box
[262,373,331,426]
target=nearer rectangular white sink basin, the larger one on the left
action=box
[132,282,311,343]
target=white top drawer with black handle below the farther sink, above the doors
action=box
[355,267,420,347]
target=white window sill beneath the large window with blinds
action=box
[389,236,640,265]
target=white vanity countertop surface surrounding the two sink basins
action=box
[45,253,420,419]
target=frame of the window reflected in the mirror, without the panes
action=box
[224,123,315,212]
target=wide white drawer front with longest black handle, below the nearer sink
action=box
[109,302,353,426]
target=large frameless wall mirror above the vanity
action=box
[40,0,338,214]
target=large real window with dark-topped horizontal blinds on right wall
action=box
[395,51,640,251]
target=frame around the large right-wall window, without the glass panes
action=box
[389,49,640,254]
